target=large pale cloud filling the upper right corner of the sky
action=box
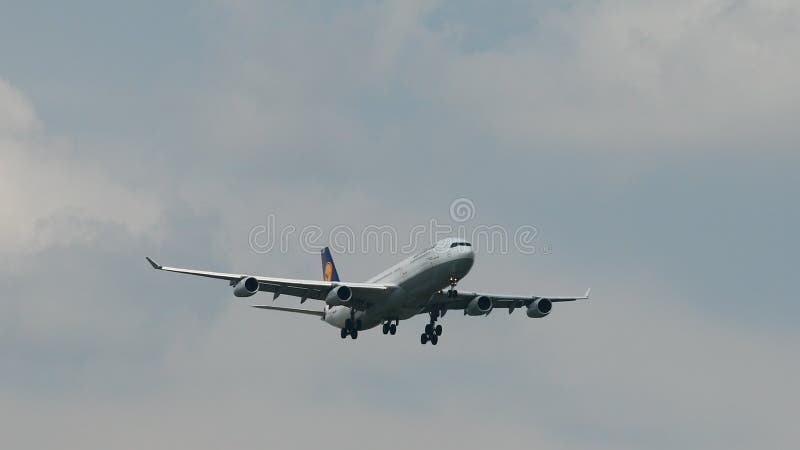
[408,1,800,153]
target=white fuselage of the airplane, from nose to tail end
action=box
[324,239,475,330]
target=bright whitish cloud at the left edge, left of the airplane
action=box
[0,80,161,265]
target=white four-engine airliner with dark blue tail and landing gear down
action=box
[146,238,591,345]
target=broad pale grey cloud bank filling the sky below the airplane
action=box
[4,265,800,449]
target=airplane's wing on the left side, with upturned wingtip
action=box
[146,258,396,309]
